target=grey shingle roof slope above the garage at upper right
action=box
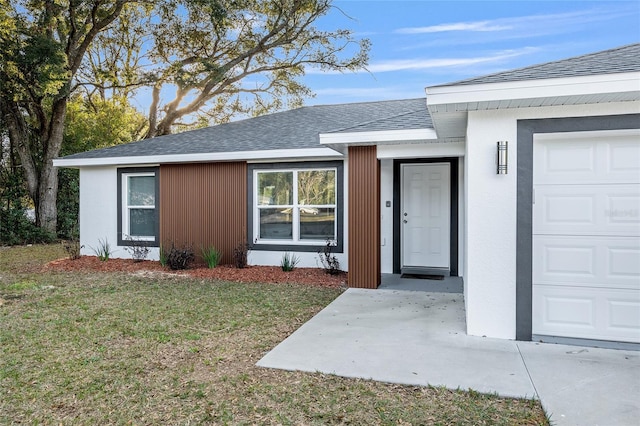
[436,43,640,87]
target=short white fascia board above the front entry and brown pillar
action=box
[320,129,438,146]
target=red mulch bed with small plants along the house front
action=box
[44,256,347,288]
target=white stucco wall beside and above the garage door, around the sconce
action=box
[464,102,640,339]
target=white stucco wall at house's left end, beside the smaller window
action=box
[80,167,159,260]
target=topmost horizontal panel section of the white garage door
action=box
[533,130,640,184]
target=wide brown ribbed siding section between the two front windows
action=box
[160,162,247,264]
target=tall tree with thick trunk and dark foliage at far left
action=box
[0,0,126,232]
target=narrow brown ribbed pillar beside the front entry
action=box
[348,146,380,288]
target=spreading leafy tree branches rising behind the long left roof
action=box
[83,0,369,137]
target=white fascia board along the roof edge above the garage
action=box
[425,72,640,108]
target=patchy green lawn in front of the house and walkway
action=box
[0,245,548,425]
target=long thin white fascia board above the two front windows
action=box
[53,147,341,167]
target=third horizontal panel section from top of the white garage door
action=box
[533,235,640,289]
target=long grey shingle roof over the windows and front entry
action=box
[64,98,432,159]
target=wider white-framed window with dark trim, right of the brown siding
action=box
[250,162,342,251]
